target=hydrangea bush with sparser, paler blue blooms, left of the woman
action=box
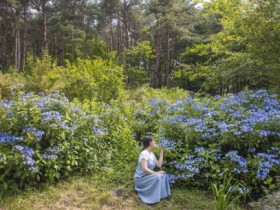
[0,92,138,196]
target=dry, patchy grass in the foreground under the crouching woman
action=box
[0,172,217,210]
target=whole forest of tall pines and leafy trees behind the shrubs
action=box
[0,0,280,97]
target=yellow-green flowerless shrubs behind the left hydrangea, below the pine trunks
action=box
[4,52,125,102]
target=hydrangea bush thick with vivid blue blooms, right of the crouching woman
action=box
[152,90,280,193]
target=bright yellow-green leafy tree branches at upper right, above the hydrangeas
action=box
[176,0,279,94]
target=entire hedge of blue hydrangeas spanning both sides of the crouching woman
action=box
[0,90,280,199]
